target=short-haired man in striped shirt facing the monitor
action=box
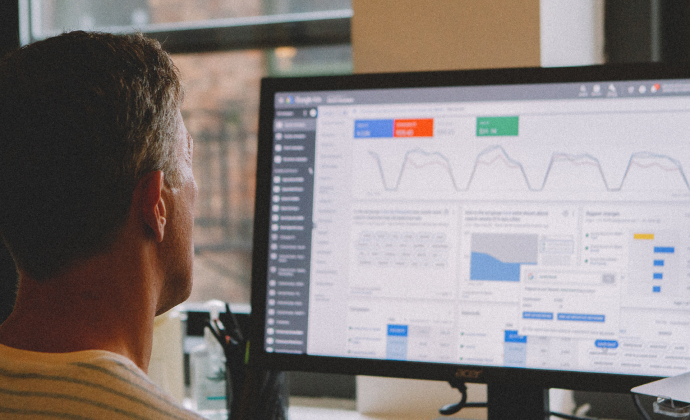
[0,32,199,419]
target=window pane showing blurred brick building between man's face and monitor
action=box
[173,46,351,303]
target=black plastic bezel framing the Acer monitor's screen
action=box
[249,63,690,392]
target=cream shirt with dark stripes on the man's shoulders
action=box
[0,344,202,420]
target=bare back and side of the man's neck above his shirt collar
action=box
[0,243,158,372]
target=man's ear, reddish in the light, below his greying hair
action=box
[135,171,168,242]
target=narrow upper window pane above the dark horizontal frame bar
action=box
[29,0,351,38]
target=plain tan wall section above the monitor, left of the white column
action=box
[352,0,541,73]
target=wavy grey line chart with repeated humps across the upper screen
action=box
[367,145,690,192]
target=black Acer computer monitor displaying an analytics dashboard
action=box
[250,65,690,416]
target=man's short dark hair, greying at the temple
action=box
[0,32,188,281]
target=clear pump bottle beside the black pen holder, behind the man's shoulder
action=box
[189,301,228,420]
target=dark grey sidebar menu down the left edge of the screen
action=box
[265,108,317,353]
